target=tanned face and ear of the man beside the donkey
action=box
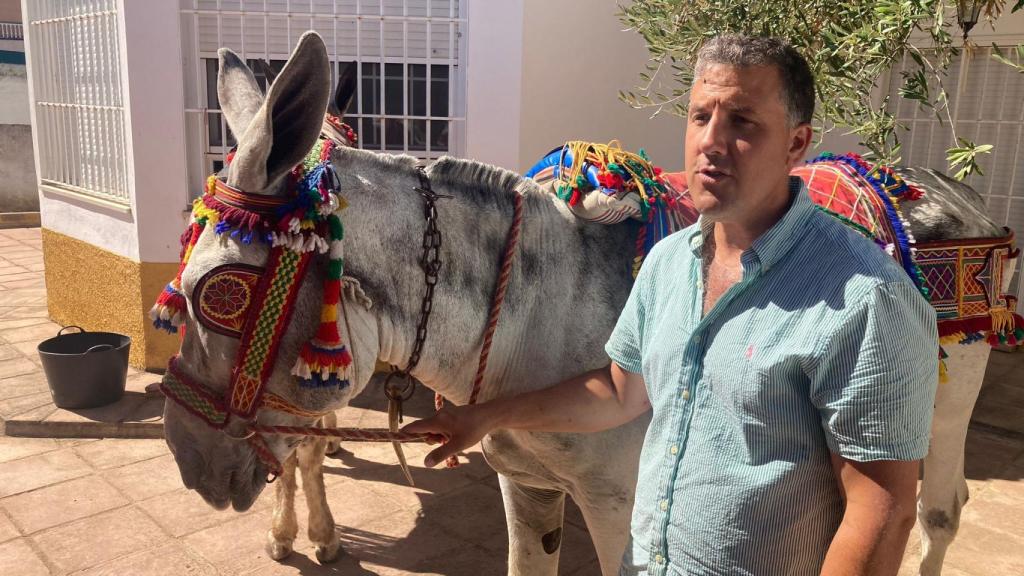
[685,65,811,222]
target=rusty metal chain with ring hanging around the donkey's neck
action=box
[384,166,451,421]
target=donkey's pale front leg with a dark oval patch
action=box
[498,475,565,576]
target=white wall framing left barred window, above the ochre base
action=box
[23,0,187,262]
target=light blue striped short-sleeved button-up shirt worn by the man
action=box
[606,179,938,576]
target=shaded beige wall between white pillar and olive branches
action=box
[509,0,683,170]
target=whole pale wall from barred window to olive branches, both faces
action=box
[466,0,683,172]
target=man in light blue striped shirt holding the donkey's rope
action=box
[407,36,938,575]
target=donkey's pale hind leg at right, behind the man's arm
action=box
[918,342,991,576]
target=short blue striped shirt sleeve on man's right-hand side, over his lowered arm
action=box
[810,282,939,461]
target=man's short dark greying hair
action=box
[693,34,814,126]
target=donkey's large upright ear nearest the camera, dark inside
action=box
[228,32,331,194]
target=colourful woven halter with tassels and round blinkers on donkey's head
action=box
[150,125,352,471]
